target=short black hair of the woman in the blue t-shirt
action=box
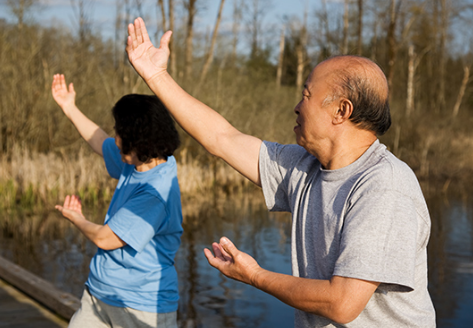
[112,94,180,163]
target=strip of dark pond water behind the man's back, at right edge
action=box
[428,193,473,327]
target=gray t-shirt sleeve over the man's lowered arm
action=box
[334,189,418,292]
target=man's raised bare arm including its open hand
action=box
[126,18,262,185]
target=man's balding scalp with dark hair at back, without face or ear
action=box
[317,56,391,135]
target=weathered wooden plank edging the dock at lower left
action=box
[0,256,80,320]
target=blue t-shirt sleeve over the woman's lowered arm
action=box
[107,192,168,252]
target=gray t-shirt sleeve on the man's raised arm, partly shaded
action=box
[259,141,305,212]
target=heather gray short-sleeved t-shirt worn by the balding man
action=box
[259,140,435,328]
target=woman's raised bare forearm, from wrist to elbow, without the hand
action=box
[64,105,109,156]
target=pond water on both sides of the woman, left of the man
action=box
[0,192,294,328]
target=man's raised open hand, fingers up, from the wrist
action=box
[126,17,172,83]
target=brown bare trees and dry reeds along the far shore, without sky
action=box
[0,0,473,212]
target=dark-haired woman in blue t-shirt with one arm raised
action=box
[52,74,182,328]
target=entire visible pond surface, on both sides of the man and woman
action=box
[0,187,473,328]
